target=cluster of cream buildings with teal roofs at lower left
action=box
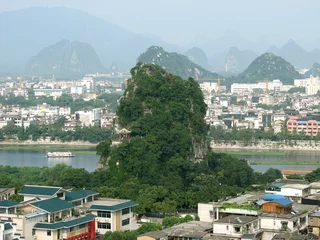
[0,185,137,240]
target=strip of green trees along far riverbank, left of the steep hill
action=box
[0,118,111,143]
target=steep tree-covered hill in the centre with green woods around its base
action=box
[0,64,281,227]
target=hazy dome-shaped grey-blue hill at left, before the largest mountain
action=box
[26,40,105,77]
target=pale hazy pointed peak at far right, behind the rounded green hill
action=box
[268,40,320,68]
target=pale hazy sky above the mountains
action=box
[0,0,320,45]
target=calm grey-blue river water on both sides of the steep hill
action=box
[0,148,320,173]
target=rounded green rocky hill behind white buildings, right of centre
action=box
[227,53,301,85]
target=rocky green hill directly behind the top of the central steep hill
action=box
[138,46,219,80]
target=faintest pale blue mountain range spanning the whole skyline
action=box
[0,7,320,74]
